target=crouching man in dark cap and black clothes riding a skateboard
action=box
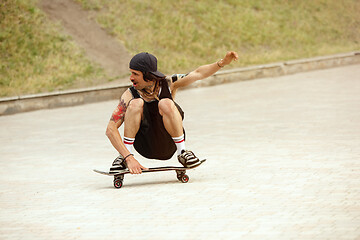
[106,52,238,174]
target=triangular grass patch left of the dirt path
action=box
[0,0,106,97]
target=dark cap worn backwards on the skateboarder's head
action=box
[129,52,165,77]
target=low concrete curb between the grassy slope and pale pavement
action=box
[0,51,360,116]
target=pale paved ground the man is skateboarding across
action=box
[0,65,360,239]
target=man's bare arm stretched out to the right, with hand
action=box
[171,51,239,94]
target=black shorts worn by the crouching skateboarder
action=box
[134,98,185,160]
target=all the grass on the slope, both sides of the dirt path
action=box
[0,0,360,96]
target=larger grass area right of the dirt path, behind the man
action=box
[77,0,360,73]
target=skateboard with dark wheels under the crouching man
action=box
[94,159,206,188]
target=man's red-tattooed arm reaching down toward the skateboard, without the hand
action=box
[106,90,132,156]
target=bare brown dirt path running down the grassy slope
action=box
[39,0,131,82]
